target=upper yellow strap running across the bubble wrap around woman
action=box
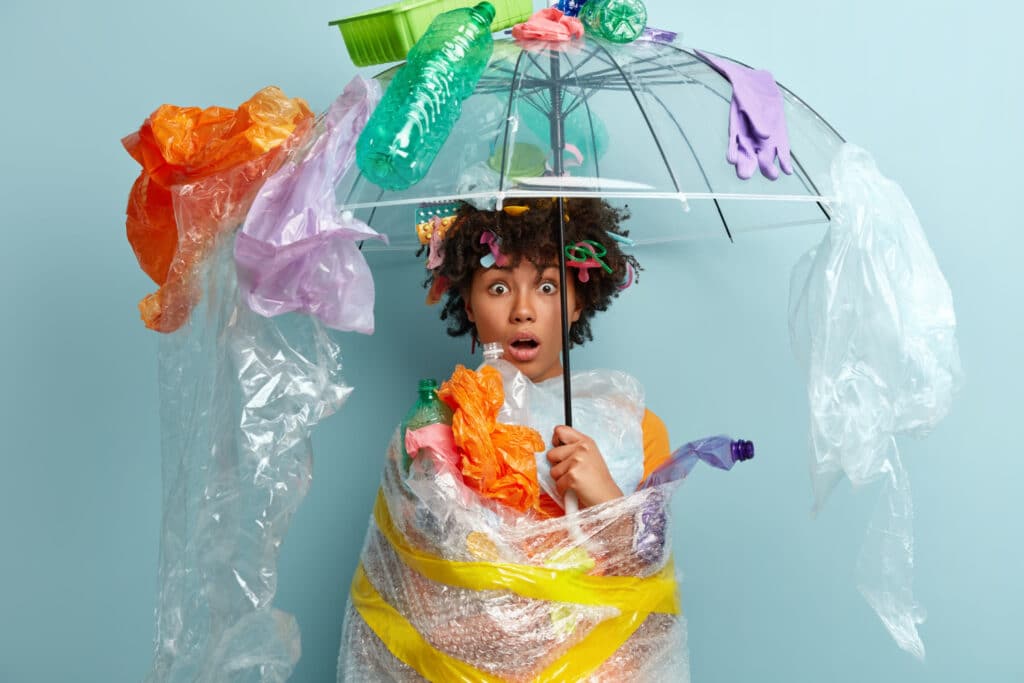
[374,493,679,614]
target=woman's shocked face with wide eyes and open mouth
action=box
[463,259,581,382]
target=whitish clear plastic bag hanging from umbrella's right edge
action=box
[791,144,961,657]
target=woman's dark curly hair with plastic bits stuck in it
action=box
[421,198,641,344]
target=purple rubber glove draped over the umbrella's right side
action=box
[697,50,793,180]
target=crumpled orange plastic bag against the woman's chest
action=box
[437,366,544,512]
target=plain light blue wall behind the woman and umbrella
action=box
[0,0,1024,683]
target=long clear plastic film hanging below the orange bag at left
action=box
[146,240,351,683]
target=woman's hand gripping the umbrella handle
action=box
[548,425,623,508]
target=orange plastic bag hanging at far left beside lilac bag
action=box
[122,87,313,332]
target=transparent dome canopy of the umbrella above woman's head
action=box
[337,38,843,249]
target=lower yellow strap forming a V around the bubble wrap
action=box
[351,564,647,683]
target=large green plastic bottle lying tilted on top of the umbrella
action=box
[355,2,495,189]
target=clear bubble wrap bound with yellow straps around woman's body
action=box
[338,368,689,682]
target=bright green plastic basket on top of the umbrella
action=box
[330,0,534,67]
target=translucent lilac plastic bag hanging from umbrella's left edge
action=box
[234,76,386,334]
